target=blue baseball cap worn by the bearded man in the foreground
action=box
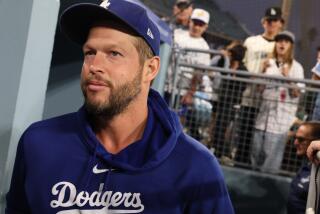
[60,0,160,56]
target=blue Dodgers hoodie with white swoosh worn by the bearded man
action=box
[6,90,234,214]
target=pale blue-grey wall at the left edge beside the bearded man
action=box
[0,0,59,213]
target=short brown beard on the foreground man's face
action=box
[81,70,142,129]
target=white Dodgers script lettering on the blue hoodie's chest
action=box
[50,181,144,214]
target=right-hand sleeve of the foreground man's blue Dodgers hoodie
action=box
[186,158,234,214]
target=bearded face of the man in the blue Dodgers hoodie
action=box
[81,27,142,119]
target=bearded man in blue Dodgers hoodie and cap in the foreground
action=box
[6,0,233,214]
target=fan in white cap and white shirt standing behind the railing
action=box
[168,8,217,139]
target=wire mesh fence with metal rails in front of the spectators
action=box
[170,49,320,175]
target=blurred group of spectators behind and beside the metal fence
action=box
[164,0,320,213]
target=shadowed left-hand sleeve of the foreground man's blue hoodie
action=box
[5,137,31,214]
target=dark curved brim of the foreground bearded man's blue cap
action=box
[60,3,135,45]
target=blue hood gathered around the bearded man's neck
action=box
[78,89,182,172]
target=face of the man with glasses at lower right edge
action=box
[294,125,312,156]
